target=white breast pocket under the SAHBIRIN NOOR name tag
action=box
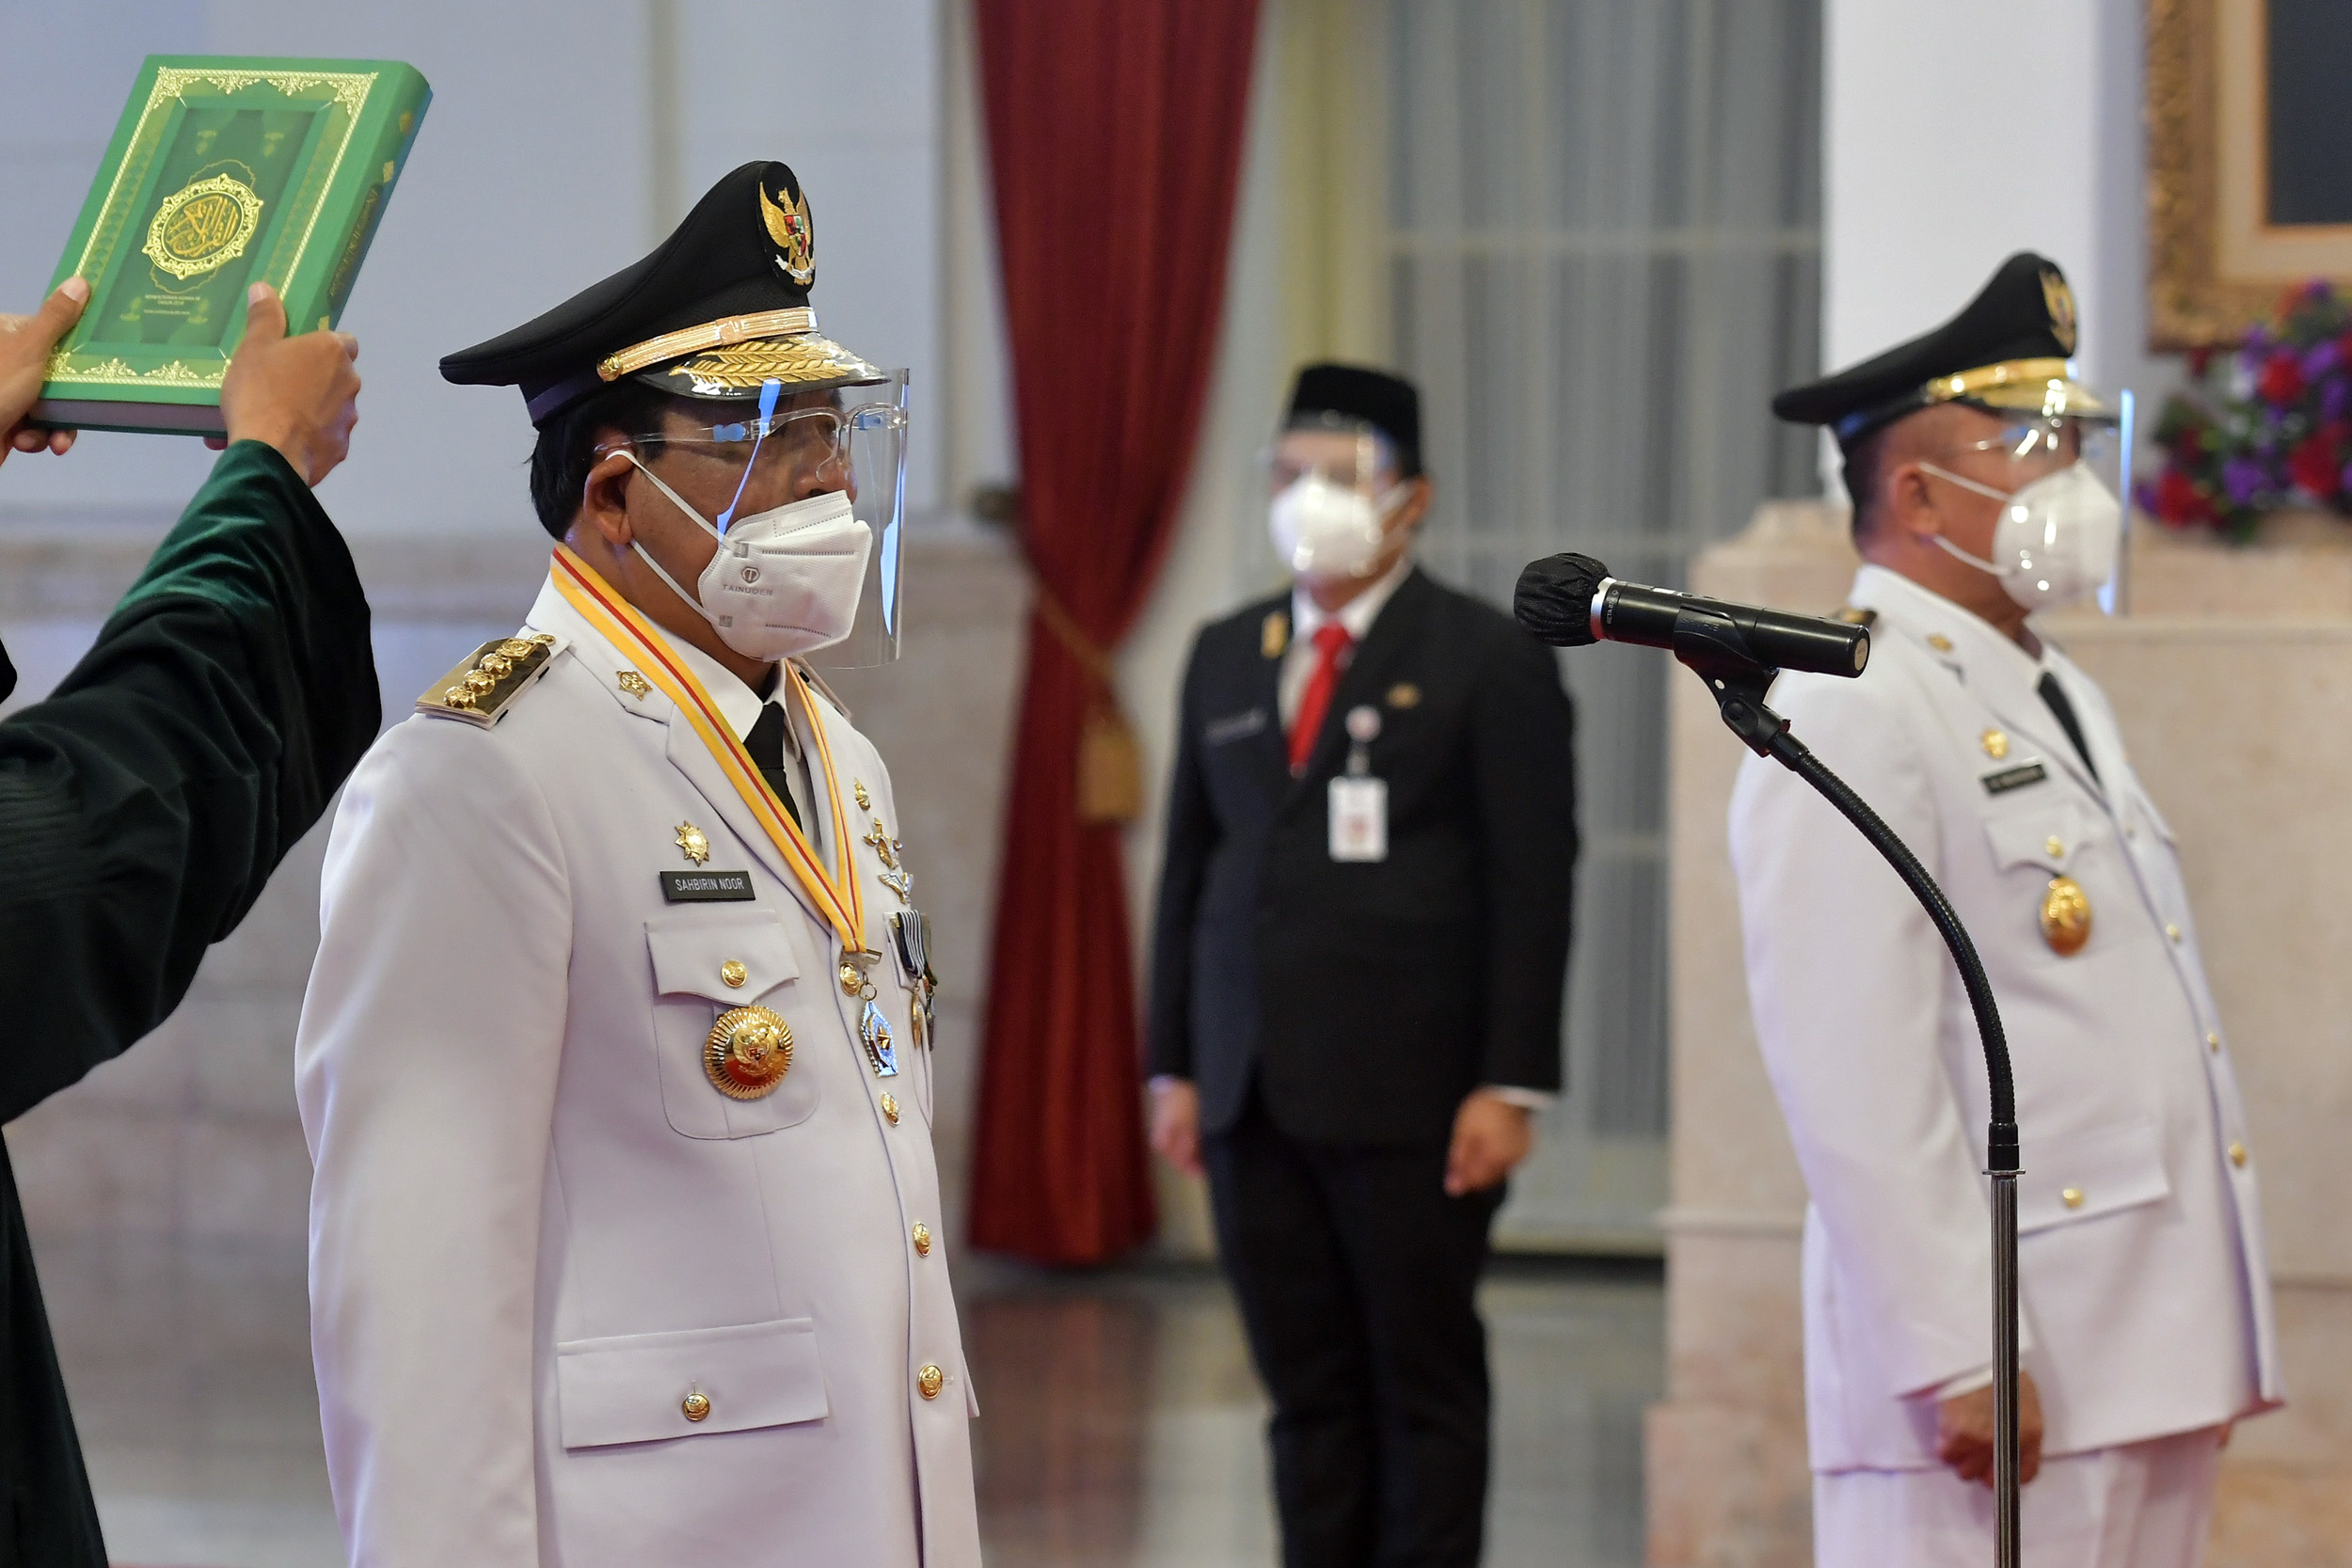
[644,905,818,1138]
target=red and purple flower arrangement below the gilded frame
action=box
[2138,279,2352,543]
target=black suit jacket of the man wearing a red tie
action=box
[1151,569,1576,1145]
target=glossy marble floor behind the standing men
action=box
[40,1243,1663,1568]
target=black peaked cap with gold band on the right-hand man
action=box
[1772,251,2110,447]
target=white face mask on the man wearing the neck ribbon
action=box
[621,449,875,663]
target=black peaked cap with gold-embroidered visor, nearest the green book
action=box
[442,162,882,425]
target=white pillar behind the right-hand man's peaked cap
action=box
[1820,0,2178,465]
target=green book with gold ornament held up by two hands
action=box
[33,54,433,435]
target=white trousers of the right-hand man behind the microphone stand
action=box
[1814,1427,2220,1568]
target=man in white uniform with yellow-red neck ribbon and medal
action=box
[299,162,978,1568]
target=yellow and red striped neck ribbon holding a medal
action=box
[548,546,866,952]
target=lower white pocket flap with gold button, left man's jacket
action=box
[555,1317,828,1449]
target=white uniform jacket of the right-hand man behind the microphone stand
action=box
[1731,566,2280,1472]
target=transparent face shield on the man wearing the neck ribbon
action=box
[628,369,908,670]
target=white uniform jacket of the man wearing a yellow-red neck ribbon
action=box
[296,571,981,1568]
